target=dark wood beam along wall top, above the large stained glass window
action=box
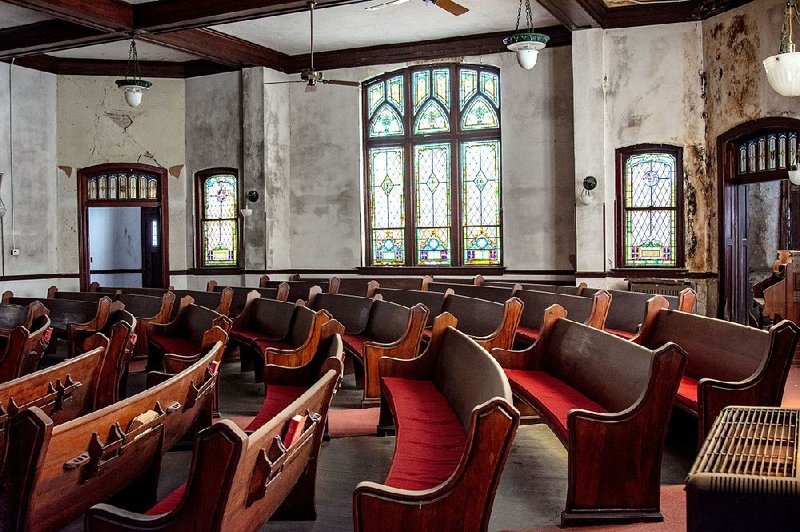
[285,26,572,73]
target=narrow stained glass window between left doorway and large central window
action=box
[196,168,239,268]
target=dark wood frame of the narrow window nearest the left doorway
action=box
[195,167,242,272]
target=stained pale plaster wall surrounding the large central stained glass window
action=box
[289,47,575,270]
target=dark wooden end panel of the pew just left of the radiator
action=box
[561,343,686,526]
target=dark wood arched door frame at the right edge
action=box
[717,117,800,323]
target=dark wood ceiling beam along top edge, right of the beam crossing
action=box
[133,0,370,32]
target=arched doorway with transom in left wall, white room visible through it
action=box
[78,163,169,290]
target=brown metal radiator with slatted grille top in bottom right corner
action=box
[686,406,800,532]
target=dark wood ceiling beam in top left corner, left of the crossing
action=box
[4,0,133,31]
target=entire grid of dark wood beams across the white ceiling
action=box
[0,0,750,77]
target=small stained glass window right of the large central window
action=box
[620,148,682,268]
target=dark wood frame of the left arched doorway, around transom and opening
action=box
[78,163,169,291]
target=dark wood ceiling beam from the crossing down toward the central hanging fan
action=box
[139,29,289,70]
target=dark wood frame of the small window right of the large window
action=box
[614,144,686,271]
